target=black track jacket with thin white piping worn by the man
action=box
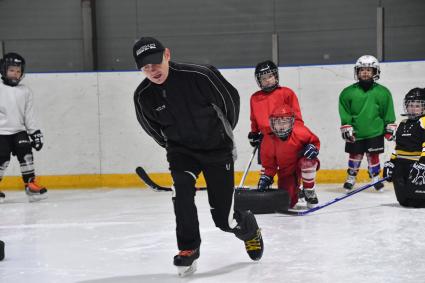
[134,61,240,159]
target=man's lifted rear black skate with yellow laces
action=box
[234,211,264,260]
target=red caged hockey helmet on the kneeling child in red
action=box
[269,104,295,140]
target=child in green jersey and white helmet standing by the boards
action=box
[339,55,397,192]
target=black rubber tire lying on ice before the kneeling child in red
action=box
[235,189,289,214]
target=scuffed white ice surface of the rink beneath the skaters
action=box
[0,184,425,283]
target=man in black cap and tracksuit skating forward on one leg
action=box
[133,37,264,276]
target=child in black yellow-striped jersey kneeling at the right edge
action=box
[384,88,425,208]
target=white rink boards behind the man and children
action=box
[6,61,425,176]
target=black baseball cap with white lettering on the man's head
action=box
[133,37,165,70]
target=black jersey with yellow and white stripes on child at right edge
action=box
[391,117,425,163]
